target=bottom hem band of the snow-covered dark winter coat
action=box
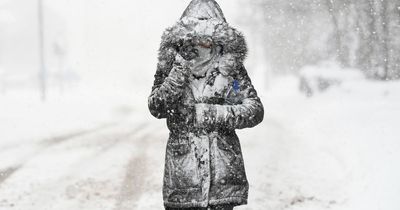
[164,197,247,208]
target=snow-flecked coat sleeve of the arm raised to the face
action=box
[148,39,188,119]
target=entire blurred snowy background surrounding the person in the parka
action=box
[0,0,400,210]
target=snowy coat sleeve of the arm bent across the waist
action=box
[195,66,264,129]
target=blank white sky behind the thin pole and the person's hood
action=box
[0,0,245,89]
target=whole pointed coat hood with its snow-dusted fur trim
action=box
[161,0,247,63]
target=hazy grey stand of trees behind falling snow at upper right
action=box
[245,0,400,80]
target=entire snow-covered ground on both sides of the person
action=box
[0,71,400,210]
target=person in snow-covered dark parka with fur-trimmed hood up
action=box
[148,0,264,210]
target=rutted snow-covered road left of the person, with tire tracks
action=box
[0,120,165,210]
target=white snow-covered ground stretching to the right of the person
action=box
[240,71,400,210]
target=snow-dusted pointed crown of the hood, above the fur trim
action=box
[181,0,226,23]
